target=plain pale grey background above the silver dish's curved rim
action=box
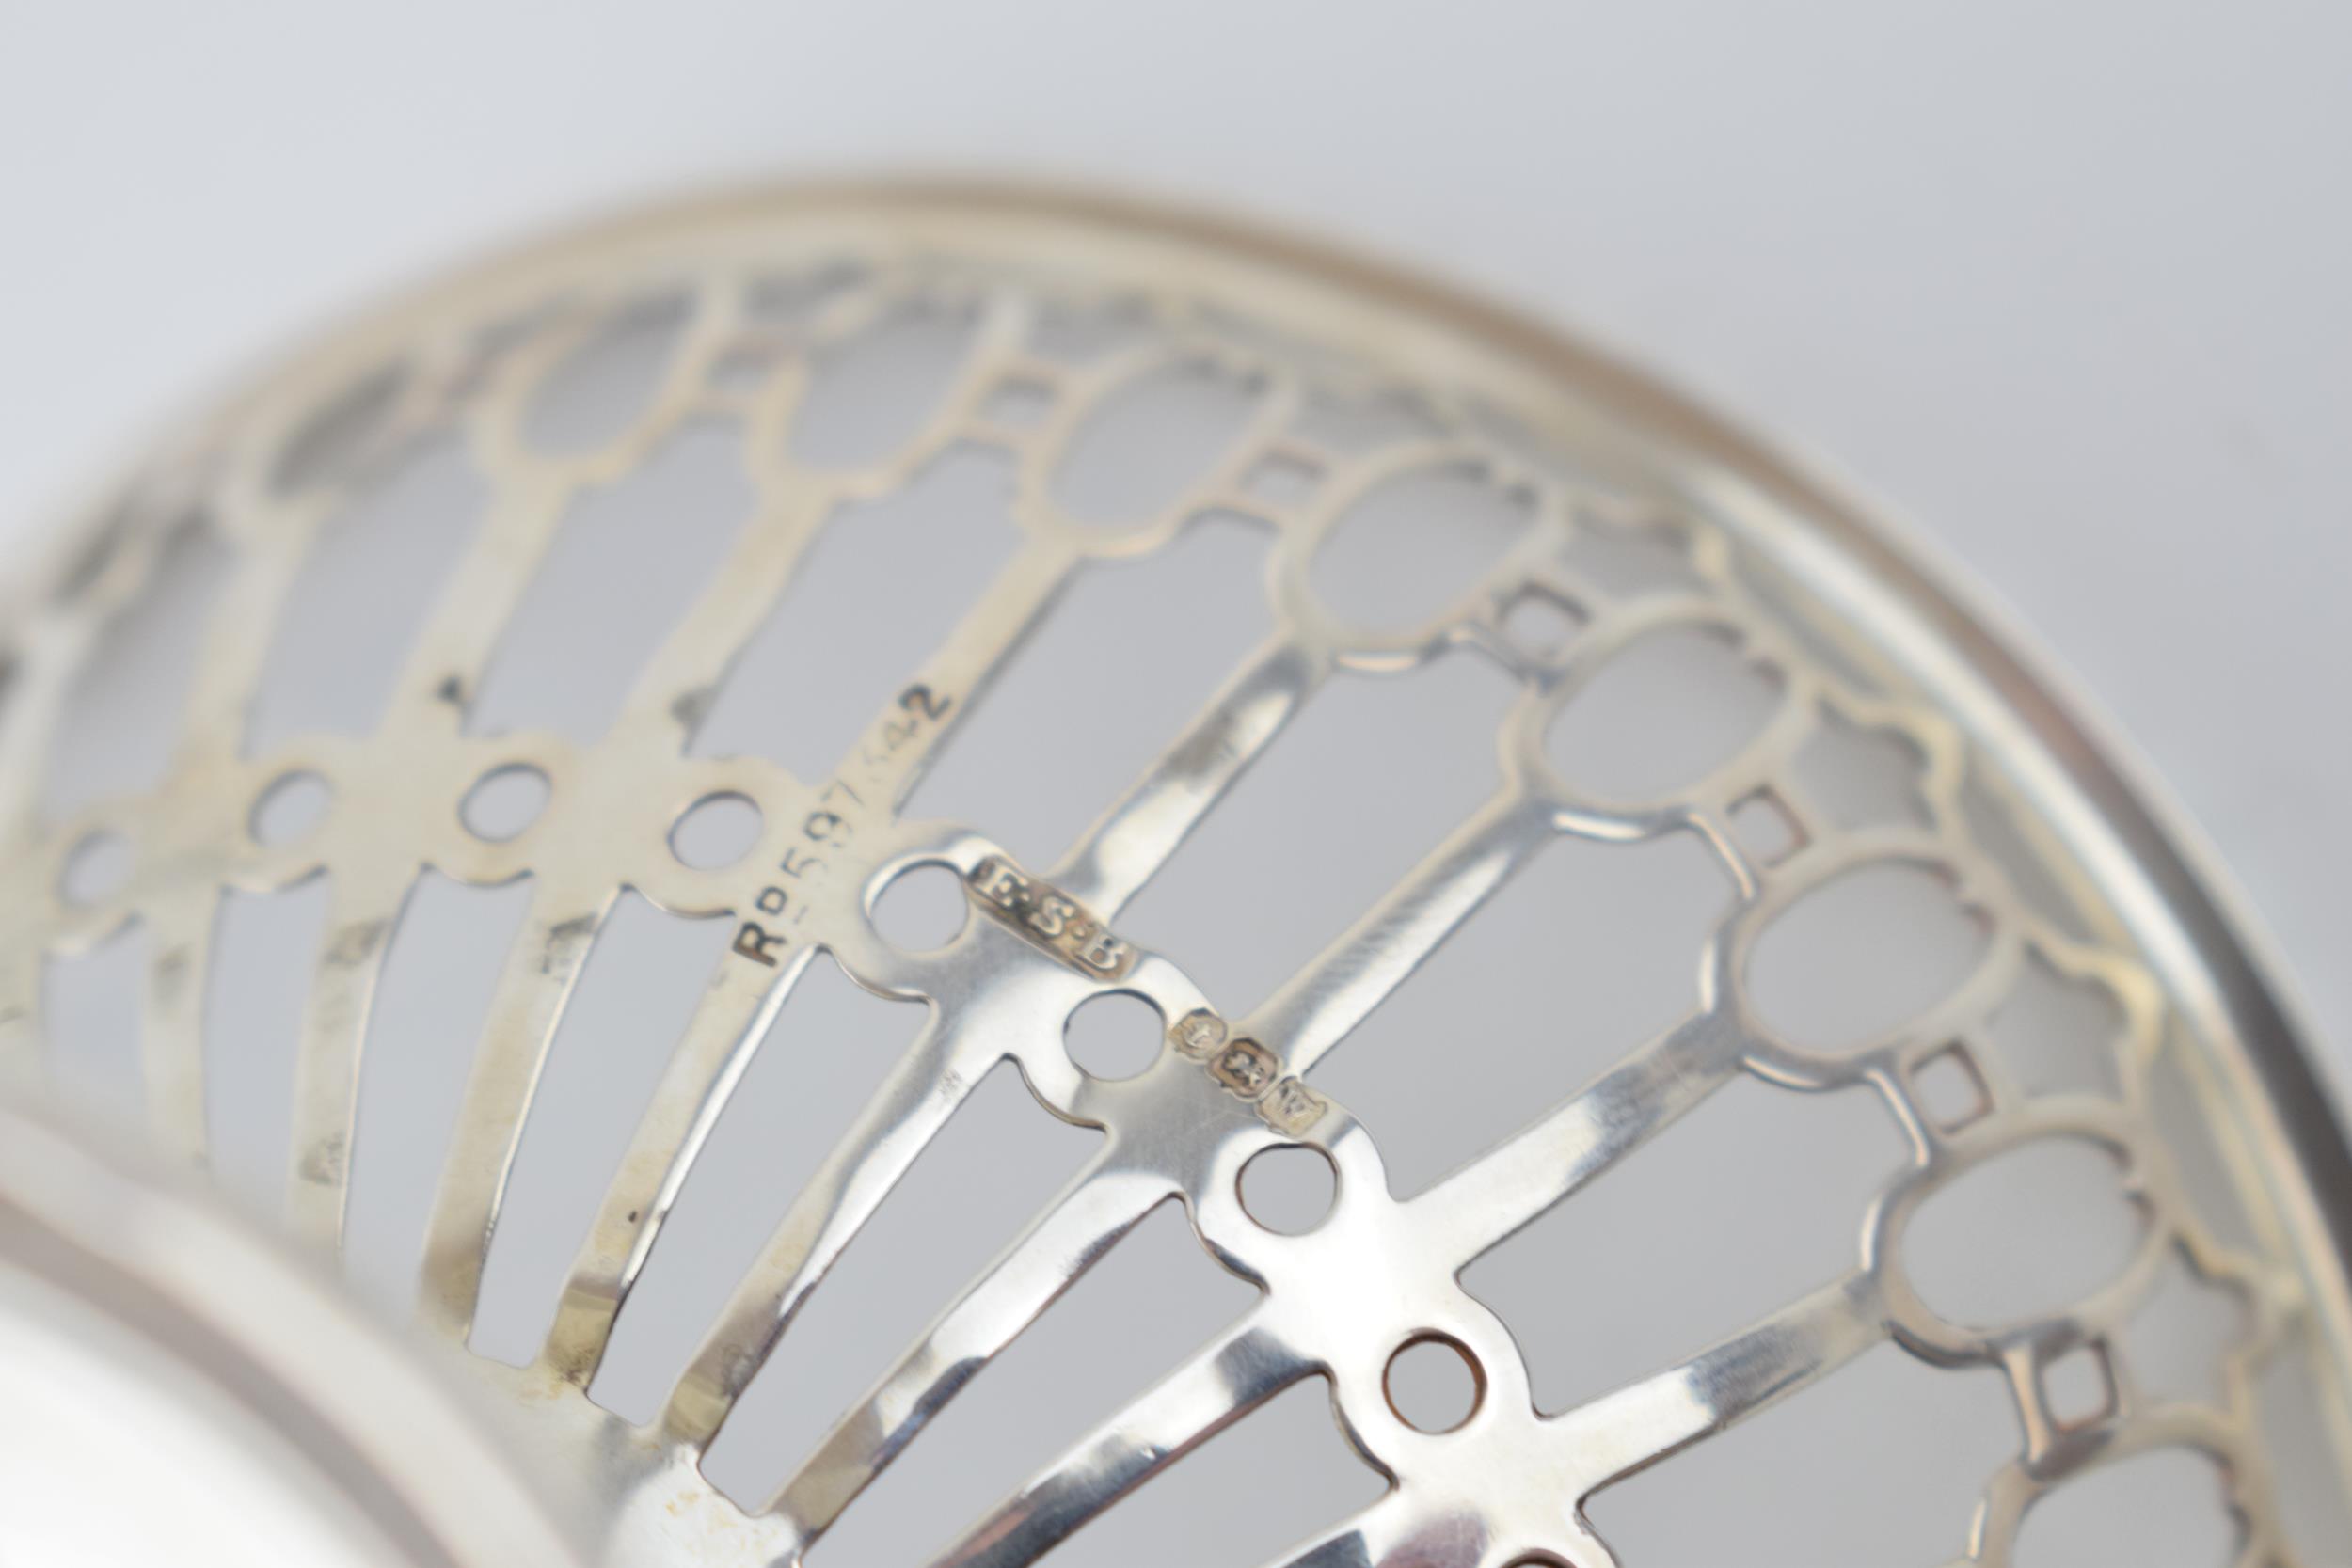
[0,0,2352,1090]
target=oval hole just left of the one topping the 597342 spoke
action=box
[793,301,978,467]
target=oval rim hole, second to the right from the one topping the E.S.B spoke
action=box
[1748,861,1985,1051]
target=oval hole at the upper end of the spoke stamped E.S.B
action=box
[1311,466,1534,632]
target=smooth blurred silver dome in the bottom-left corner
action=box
[0,1107,583,1568]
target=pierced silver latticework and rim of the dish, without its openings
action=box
[0,190,2352,1568]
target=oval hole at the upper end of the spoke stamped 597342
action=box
[1054,364,1259,527]
